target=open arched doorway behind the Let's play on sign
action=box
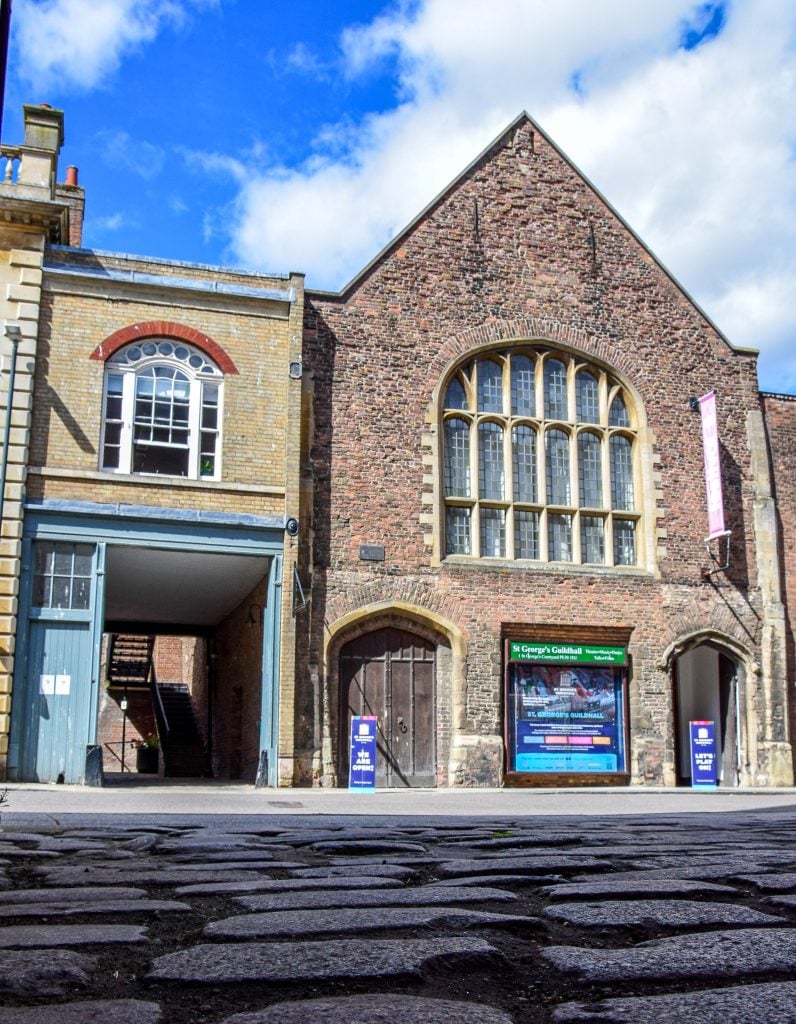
[672,643,741,786]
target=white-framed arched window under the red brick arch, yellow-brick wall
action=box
[100,338,223,480]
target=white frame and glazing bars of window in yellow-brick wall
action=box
[99,338,223,481]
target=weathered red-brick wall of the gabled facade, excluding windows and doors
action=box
[297,123,774,781]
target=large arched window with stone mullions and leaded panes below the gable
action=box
[441,345,640,565]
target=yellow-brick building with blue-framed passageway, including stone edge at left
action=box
[0,108,303,784]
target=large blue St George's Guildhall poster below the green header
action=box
[508,660,625,772]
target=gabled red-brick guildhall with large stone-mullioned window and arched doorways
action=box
[297,116,793,785]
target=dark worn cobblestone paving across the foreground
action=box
[0,810,796,1024]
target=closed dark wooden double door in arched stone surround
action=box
[340,629,436,787]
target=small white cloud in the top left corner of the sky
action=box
[13,0,215,89]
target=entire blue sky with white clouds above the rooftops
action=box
[3,0,796,393]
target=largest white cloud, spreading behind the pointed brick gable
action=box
[211,0,796,386]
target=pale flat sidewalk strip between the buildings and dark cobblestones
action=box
[6,778,796,824]
